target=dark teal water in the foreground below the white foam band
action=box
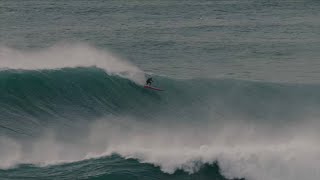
[0,155,234,180]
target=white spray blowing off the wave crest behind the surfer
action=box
[0,43,145,84]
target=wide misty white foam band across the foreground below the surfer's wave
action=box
[0,118,320,180]
